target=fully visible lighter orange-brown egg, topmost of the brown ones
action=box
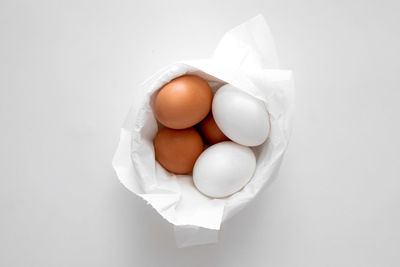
[154,75,213,129]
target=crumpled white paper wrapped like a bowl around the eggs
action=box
[113,15,294,247]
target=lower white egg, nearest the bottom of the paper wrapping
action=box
[193,141,256,198]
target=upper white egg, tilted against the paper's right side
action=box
[212,84,270,146]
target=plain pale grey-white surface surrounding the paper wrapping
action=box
[0,0,400,267]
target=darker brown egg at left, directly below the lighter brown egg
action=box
[154,128,204,174]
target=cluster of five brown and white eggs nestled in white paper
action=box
[154,75,270,198]
